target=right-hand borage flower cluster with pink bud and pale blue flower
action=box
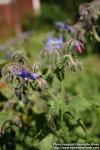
[42,38,83,79]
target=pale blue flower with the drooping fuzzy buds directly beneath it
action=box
[40,37,63,68]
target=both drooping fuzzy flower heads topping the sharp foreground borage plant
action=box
[2,25,83,102]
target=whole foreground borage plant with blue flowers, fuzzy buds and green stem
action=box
[2,33,86,148]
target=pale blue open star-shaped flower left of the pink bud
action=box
[46,37,63,48]
